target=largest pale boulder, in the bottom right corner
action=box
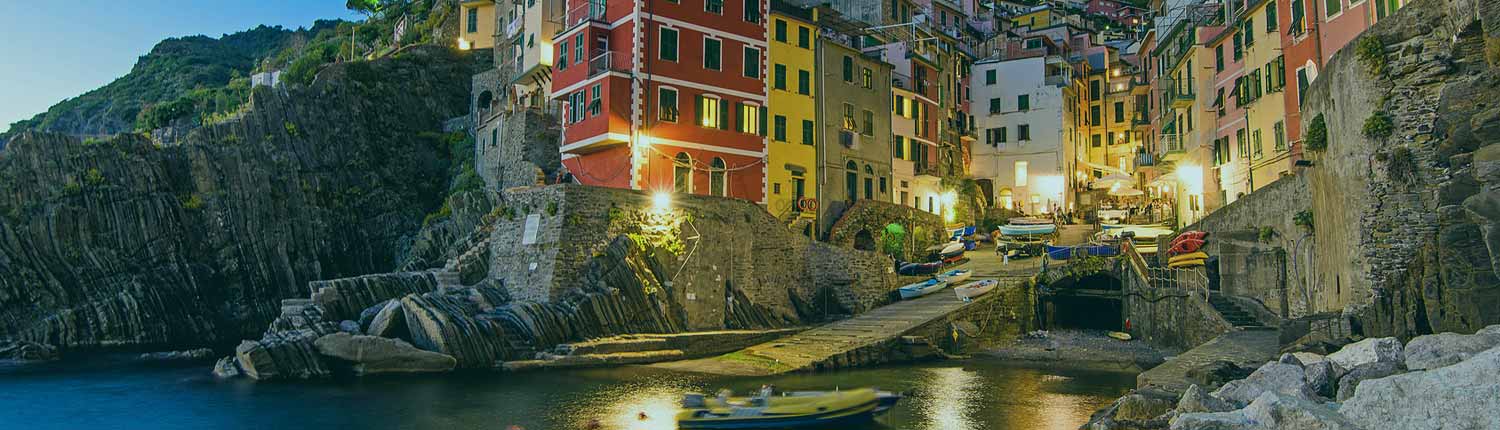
[1340,348,1500,430]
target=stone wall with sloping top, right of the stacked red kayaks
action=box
[1184,174,1308,319]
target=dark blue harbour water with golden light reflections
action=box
[0,360,1136,430]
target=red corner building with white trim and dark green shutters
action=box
[552,0,767,202]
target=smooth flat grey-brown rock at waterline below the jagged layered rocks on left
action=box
[314,333,458,375]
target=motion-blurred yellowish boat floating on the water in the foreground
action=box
[677,388,902,429]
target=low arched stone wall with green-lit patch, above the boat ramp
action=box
[828,199,948,261]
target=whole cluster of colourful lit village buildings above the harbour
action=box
[458,0,1406,235]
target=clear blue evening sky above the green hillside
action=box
[0,0,359,130]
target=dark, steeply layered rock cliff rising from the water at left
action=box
[0,46,488,349]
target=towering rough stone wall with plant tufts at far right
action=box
[1302,0,1500,337]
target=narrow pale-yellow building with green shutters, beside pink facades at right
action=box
[1235,0,1292,190]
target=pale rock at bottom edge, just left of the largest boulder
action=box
[1172,391,1376,430]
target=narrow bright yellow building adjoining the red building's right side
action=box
[765,1,818,219]
